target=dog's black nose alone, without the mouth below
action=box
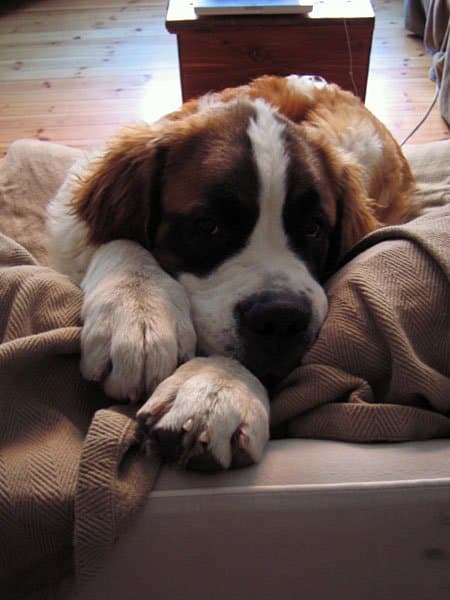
[236,293,311,343]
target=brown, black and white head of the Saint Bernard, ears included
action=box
[75,77,380,384]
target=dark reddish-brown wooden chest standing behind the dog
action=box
[166,0,375,100]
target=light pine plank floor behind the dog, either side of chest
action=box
[0,0,449,156]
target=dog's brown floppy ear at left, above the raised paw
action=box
[72,124,164,248]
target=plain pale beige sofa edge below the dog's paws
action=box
[85,439,450,600]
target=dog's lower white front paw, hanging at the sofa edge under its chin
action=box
[137,357,269,470]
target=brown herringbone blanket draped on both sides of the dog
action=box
[0,142,450,598]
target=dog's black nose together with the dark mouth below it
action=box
[234,290,314,388]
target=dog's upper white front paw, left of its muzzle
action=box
[81,277,196,402]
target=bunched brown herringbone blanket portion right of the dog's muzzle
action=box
[272,207,450,442]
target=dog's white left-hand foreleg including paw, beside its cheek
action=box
[81,240,196,401]
